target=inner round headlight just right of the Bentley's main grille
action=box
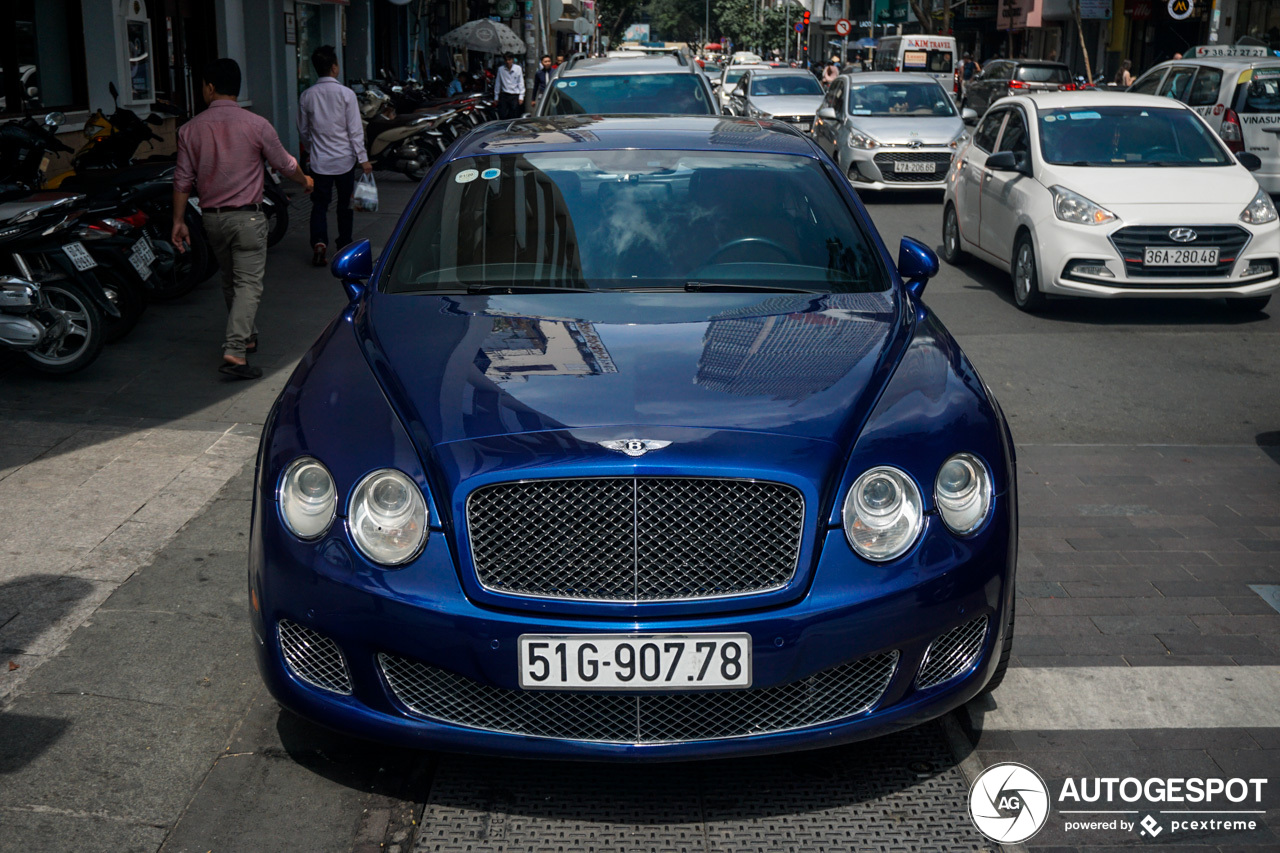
[844,467,923,562]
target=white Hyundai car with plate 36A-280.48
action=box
[942,92,1280,313]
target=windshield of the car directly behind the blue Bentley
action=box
[545,72,716,115]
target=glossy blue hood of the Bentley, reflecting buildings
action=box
[357,291,910,446]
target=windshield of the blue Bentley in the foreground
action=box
[383,153,888,293]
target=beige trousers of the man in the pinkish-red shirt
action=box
[205,210,268,359]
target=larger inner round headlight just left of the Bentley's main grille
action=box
[347,467,426,566]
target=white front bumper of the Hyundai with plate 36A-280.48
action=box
[1037,213,1280,298]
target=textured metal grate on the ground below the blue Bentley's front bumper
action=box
[406,724,996,853]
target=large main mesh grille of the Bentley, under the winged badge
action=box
[467,478,804,601]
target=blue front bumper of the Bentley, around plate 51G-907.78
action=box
[250,496,1016,760]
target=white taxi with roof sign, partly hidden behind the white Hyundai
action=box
[1129,45,1280,196]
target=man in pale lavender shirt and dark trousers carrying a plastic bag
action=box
[298,45,374,266]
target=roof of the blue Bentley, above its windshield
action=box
[451,115,815,160]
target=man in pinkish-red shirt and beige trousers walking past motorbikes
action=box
[172,59,314,379]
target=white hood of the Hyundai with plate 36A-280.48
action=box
[1042,165,1258,207]
